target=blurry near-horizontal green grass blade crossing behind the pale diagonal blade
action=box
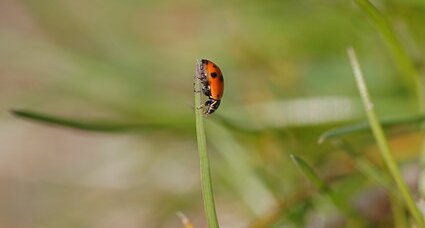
[318,116,425,143]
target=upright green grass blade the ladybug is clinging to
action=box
[194,61,219,228]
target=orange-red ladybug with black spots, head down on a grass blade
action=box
[198,59,224,115]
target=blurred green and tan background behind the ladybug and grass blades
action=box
[0,0,425,228]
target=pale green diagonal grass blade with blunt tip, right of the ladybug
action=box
[348,48,425,227]
